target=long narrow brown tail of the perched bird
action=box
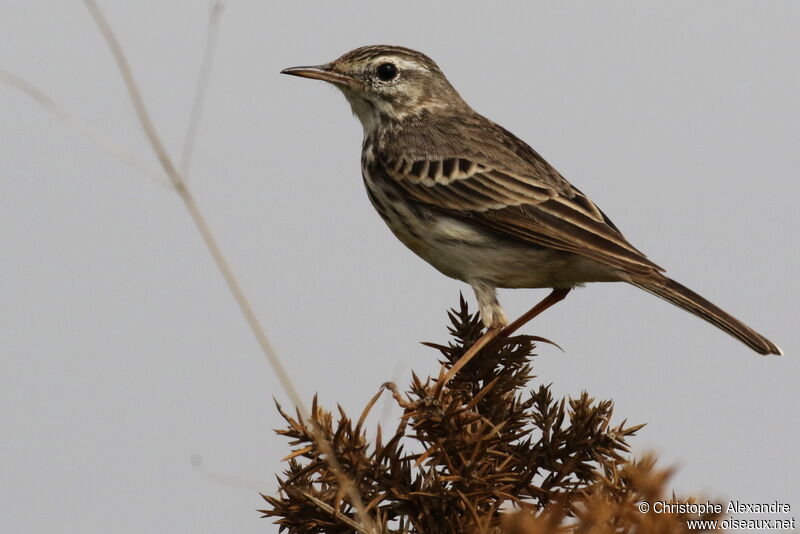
[631,277,783,355]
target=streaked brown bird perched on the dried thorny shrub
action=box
[281,45,783,372]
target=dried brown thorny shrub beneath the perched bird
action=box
[262,298,720,534]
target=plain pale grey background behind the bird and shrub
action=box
[0,0,800,533]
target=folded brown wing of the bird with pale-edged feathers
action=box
[378,154,663,276]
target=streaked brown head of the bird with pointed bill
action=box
[281,45,466,133]
